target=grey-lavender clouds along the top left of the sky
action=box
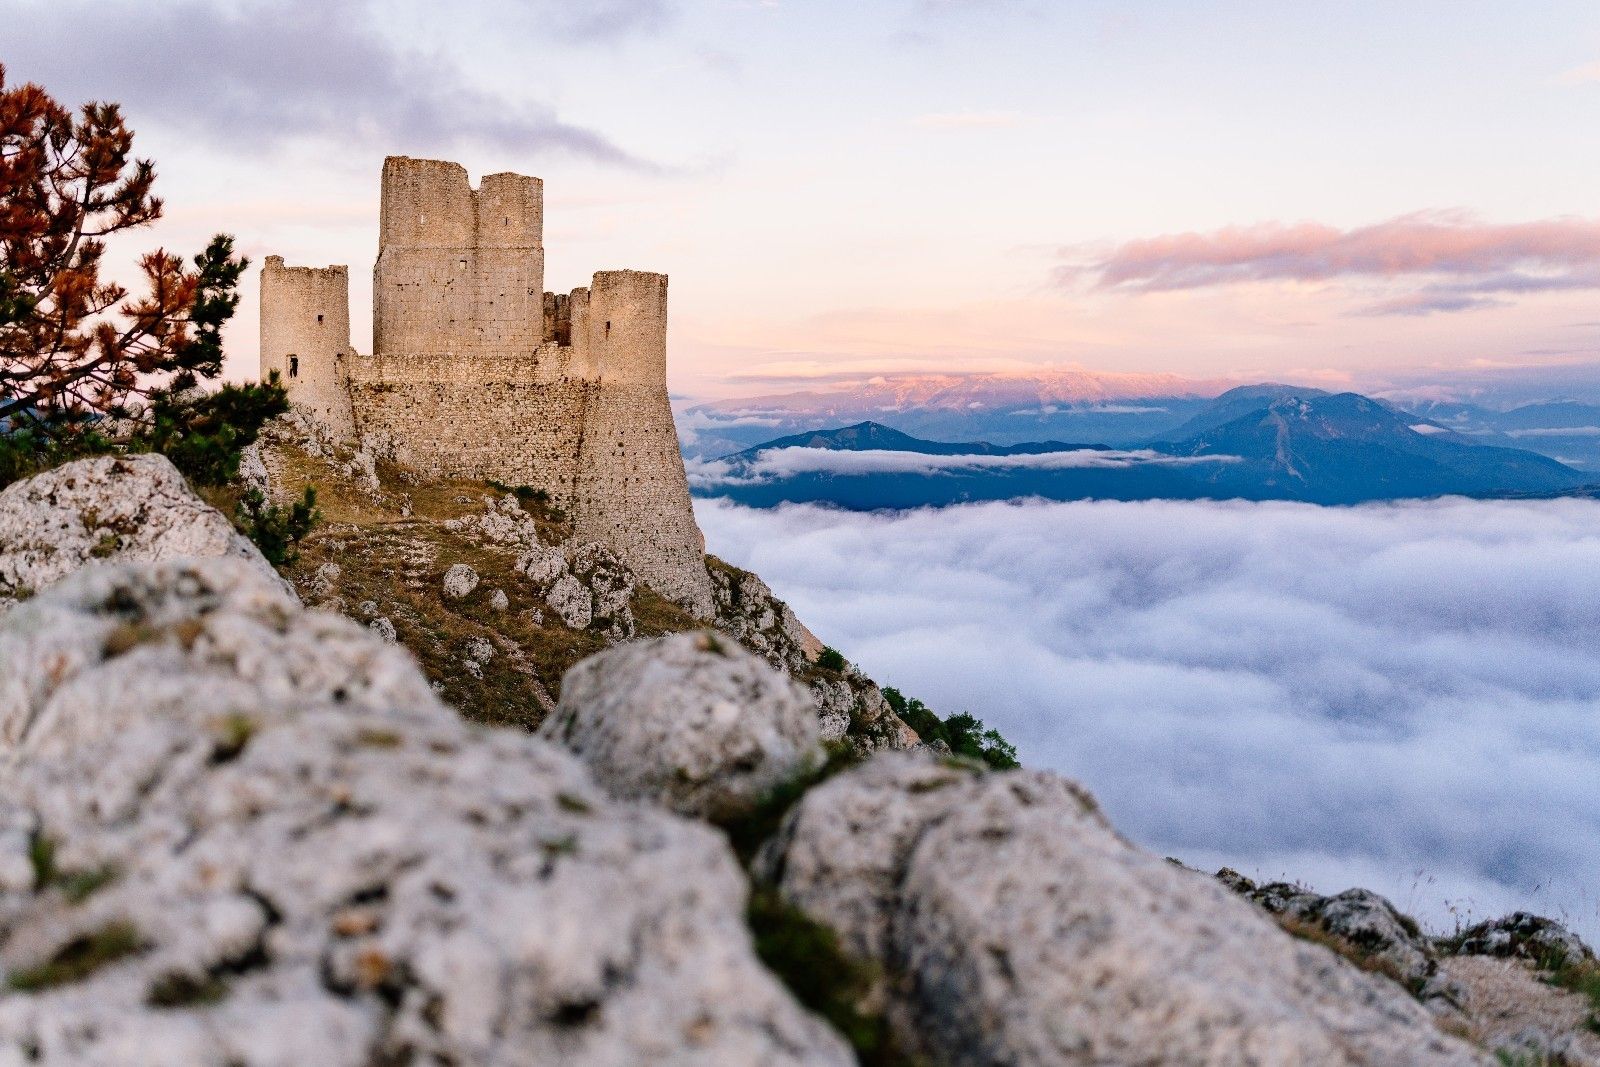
[5,0,664,170]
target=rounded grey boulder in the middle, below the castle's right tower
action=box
[539,633,822,816]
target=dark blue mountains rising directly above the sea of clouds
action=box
[690,384,1594,510]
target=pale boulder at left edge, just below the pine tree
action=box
[0,454,288,611]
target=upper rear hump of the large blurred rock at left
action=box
[0,558,446,758]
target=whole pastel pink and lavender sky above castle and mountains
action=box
[9,0,1600,395]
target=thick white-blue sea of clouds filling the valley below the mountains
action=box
[696,501,1600,942]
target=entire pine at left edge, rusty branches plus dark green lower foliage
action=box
[0,67,286,495]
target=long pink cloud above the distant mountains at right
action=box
[1088,211,1600,314]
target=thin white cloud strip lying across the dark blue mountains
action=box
[688,448,1238,488]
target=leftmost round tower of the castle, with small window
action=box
[261,256,355,440]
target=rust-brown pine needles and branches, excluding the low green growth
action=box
[0,66,227,426]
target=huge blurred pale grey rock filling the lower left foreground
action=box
[0,560,851,1067]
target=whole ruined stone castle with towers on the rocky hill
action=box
[261,157,712,617]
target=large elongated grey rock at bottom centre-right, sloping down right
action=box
[763,755,1493,1065]
